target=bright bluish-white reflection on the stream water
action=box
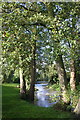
[34,81,57,107]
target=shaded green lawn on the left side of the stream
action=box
[2,84,73,119]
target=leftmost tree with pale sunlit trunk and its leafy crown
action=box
[2,2,31,99]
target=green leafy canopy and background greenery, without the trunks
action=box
[2,2,80,110]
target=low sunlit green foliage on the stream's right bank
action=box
[48,84,80,111]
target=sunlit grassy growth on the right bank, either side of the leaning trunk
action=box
[48,83,80,110]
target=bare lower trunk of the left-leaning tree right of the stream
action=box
[56,55,69,103]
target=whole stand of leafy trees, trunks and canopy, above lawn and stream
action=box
[2,2,80,118]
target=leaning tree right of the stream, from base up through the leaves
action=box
[47,3,69,103]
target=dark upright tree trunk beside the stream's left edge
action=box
[29,28,37,101]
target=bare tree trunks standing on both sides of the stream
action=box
[20,3,80,114]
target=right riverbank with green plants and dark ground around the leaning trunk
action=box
[47,83,80,111]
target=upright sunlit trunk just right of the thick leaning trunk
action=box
[70,60,76,91]
